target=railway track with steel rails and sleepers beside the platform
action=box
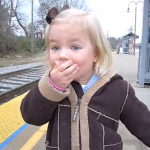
[0,65,44,104]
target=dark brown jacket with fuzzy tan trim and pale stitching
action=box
[21,70,150,150]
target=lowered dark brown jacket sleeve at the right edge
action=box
[120,84,150,147]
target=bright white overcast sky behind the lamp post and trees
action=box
[28,0,143,41]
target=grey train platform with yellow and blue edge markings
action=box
[0,55,150,150]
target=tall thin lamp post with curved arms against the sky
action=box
[127,1,143,55]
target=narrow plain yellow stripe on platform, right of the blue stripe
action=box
[20,124,47,150]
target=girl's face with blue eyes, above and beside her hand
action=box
[49,23,96,84]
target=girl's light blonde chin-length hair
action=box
[45,9,112,75]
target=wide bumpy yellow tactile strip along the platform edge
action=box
[0,93,27,143]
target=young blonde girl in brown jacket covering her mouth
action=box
[21,5,150,150]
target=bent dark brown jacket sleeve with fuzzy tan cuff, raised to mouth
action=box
[20,71,70,126]
